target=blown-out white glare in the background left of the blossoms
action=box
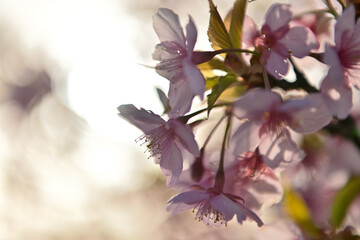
[0,0,166,192]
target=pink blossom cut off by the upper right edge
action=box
[321,5,360,119]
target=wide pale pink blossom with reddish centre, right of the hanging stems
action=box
[232,89,331,164]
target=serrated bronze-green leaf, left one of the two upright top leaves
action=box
[208,0,232,50]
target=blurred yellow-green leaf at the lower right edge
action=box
[330,176,360,228]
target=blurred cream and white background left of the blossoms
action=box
[0,0,354,240]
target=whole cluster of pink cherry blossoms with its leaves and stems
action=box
[118,0,360,236]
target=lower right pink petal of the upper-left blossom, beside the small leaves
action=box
[183,58,205,100]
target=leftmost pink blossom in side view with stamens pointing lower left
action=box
[118,104,199,185]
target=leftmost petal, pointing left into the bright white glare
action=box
[117,104,166,132]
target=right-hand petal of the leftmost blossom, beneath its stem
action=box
[168,119,200,157]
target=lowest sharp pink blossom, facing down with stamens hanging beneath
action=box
[167,188,263,227]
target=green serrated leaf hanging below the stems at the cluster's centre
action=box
[207,75,237,115]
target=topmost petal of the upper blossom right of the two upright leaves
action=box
[265,3,292,32]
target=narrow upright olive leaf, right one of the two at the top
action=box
[229,0,248,48]
